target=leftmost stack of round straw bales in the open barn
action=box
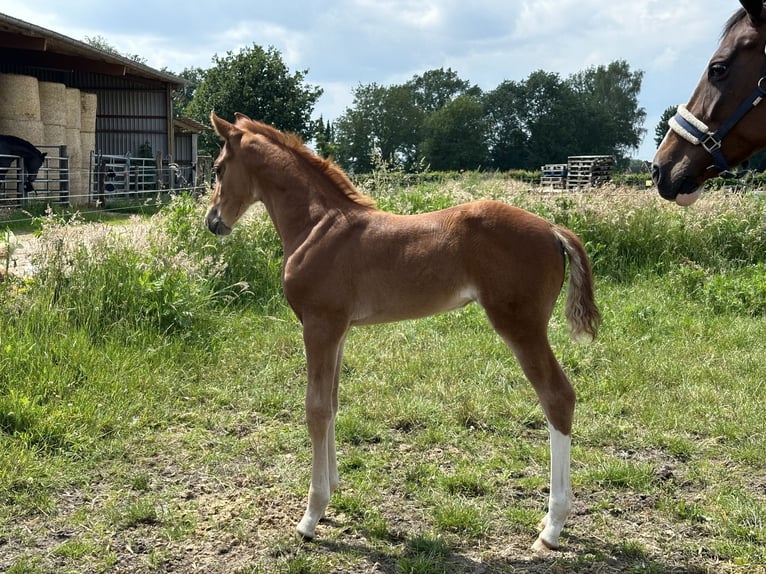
[0,74,45,145]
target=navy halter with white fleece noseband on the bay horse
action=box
[668,44,766,172]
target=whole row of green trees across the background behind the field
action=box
[174,45,646,173]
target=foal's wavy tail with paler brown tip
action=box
[552,225,601,340]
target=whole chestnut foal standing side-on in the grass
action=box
[206,114,600,550]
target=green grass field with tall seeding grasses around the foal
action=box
[0,178,766,574]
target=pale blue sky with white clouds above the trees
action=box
[0,0,739,159]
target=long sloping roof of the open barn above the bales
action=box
[0,13,187,87]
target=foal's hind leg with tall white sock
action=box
[490,315,575,550]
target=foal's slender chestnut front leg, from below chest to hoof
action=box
[297,320,346,538]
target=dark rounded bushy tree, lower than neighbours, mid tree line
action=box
[422,95,487,171]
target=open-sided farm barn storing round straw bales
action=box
[0,13,206,207]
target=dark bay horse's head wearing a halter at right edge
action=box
[652,0,766,205]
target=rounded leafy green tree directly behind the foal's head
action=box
[186,44,322,155]
